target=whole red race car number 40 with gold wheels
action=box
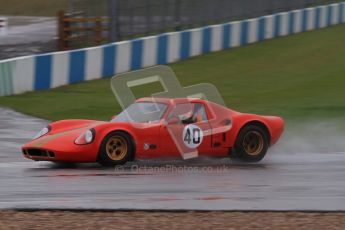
[22,98,284,166]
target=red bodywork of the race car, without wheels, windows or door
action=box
[22,98,284,162]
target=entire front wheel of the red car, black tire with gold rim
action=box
[98,131,135,167]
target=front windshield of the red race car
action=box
[111,102,167,123]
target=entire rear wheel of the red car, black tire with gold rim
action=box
[232,125,269,162]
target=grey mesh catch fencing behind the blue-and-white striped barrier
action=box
[70,0,340,42]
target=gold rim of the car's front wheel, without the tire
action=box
[106,136,128,161]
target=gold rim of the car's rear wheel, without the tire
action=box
[242,131,264,156]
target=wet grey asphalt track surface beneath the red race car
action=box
[0,109,345,210]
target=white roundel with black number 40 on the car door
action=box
[182,124,204,149]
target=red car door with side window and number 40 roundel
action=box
[160,103,212,159]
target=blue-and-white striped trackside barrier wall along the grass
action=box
[0,2,345,96]
